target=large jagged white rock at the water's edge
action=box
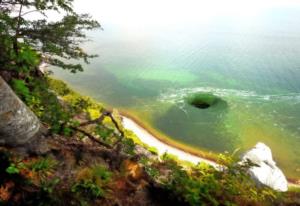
[242,142,288,192]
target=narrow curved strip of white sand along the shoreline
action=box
[122,116,217,167]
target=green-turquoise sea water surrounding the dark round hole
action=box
[55,6,300,179]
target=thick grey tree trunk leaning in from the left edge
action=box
[0,76,42,147]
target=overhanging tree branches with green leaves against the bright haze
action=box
[0,0,100,74]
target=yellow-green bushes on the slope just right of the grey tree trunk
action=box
[11,77,110,140]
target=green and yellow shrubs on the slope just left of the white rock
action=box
[159,156,277,205]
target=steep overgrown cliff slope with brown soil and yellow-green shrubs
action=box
[0,78,297,205]
